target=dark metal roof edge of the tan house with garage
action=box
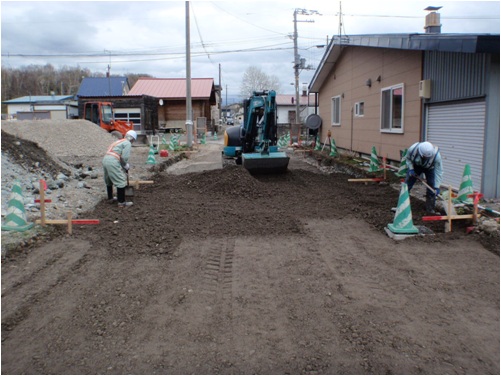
[309,33,499,93]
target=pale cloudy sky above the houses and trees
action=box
[1,0,500,99]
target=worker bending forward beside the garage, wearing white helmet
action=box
[405,141,443,215]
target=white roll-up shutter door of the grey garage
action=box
[427,101,485,191]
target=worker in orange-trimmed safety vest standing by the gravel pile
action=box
[103,130,137,207]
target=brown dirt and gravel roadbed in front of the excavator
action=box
[2,127,500,374]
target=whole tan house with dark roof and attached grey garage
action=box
[309,32,500,198]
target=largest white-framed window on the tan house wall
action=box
[381,84,404,133]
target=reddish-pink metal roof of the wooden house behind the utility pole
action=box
[129,78,214,99]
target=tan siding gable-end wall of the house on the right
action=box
[311,46,422,160]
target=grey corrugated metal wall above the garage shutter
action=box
[423,51,489,103]
